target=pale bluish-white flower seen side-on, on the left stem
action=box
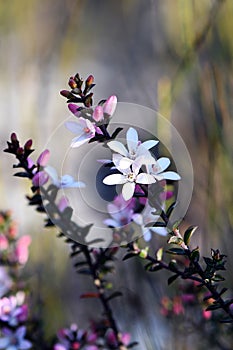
[44,166,85,188]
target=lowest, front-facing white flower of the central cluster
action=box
[103,162,156,201]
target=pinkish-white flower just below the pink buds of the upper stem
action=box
[65,117,96,148]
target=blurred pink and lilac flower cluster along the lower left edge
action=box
[0,212,32,350]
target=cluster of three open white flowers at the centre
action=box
[103,127,180,201]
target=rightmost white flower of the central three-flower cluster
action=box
[147,157,181,181]
